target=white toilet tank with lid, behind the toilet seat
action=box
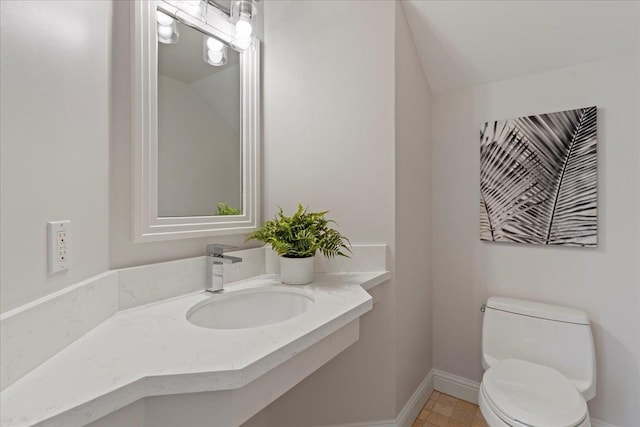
[482,297,596,400]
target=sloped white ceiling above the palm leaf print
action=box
[402,0,640,93]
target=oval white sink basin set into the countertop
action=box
[187,288,314,329]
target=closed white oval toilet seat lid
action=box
[480,359,588,427]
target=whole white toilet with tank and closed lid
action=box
[478,297,596,427]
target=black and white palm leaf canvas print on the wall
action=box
[480,107,598,247]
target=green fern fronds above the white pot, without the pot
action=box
[247,204,351,258]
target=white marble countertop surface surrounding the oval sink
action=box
[0,272,390,426]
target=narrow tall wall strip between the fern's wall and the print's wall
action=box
[395,3,433,413]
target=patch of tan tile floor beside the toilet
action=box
[413,391,487,427]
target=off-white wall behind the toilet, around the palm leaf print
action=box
[432,56,640,426]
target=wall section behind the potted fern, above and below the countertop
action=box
[263,1,395,427]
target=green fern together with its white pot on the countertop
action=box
[247,204,351,285]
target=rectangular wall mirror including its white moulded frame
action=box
[132,1,260,242]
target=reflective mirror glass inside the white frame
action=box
[158,24,243,217]
